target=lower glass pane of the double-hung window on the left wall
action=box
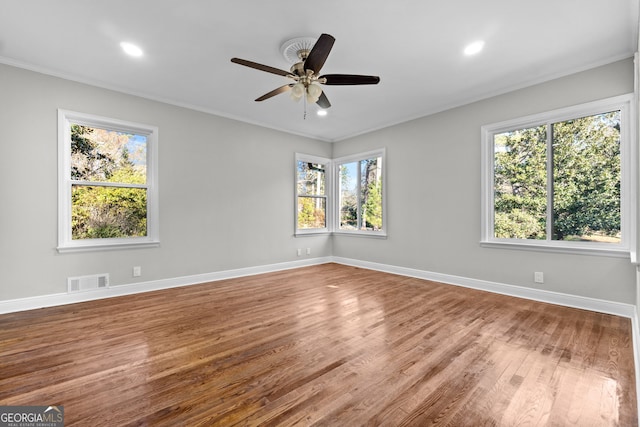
[71,185,147,240]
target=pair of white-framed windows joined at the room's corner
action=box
[295,150,386,237]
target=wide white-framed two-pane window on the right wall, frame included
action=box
[482,96,635,256]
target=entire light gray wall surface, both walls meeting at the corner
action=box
[0,60,636,304]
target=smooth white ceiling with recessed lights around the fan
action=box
[0,0,639,141]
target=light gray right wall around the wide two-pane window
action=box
[333,60,636,304]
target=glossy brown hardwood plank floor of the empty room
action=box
[0,264,638,427]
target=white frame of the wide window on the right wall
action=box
[480,94,637,258]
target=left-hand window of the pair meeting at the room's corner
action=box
[296,155,331,234]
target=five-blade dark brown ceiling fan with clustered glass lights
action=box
[231,34,380,108]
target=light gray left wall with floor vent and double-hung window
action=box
[0,65,331,300]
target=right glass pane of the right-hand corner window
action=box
[359,157,382,231]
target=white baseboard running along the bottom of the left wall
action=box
[0,257,331,314]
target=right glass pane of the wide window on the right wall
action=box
[553,111,621,243]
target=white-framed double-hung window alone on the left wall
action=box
[58,110,158,252]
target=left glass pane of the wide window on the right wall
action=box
[493,125,547,239]
